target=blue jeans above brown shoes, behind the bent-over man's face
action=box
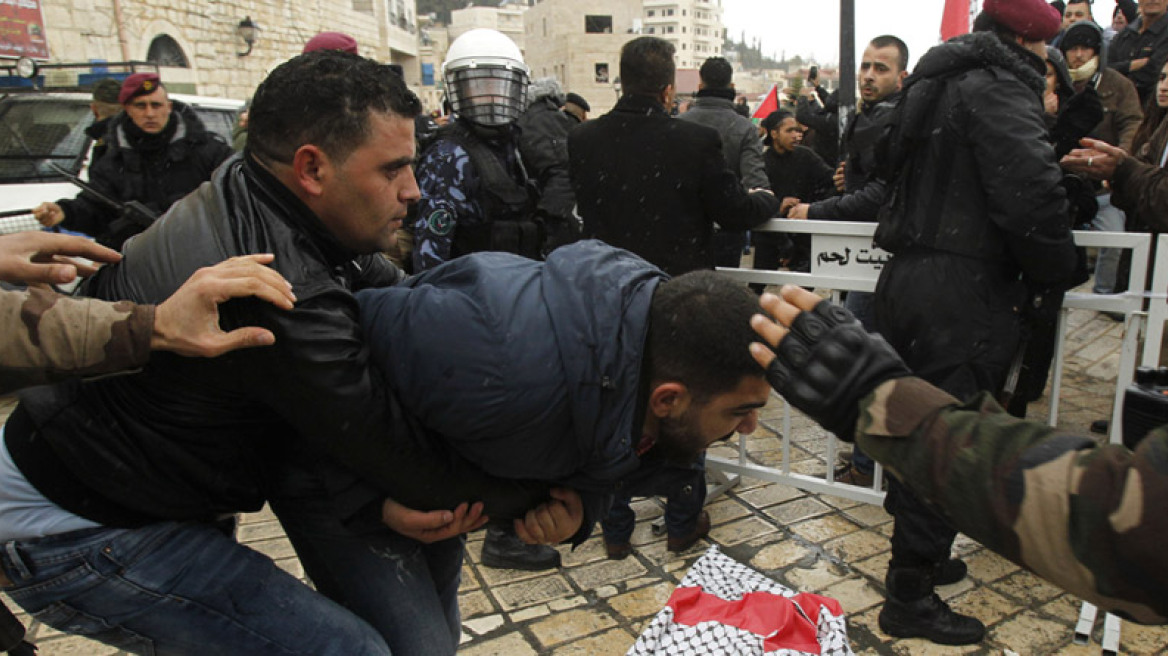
[600,455,705,544]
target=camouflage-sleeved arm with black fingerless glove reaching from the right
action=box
[751,286,1168,623]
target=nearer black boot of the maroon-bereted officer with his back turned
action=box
[880,566,986,644]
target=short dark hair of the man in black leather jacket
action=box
[246,50,422,163]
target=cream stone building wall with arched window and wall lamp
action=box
[27,0,422,99]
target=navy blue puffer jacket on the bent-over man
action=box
[357,240,667,526]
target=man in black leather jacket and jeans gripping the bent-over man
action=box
[0,51,555,654]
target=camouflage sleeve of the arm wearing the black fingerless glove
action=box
[856,378,1168,623]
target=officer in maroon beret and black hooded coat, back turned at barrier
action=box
[876,0,1076,644]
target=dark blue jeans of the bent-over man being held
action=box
[271,462,464,656]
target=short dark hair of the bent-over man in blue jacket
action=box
[646,271,764,403]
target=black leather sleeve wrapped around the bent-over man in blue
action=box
[232,277,547,518]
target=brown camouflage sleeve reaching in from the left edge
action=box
[0,288,154,393]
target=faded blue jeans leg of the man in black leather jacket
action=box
[0,522,389,656]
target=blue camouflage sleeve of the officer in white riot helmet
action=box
[413,141,482,272]
